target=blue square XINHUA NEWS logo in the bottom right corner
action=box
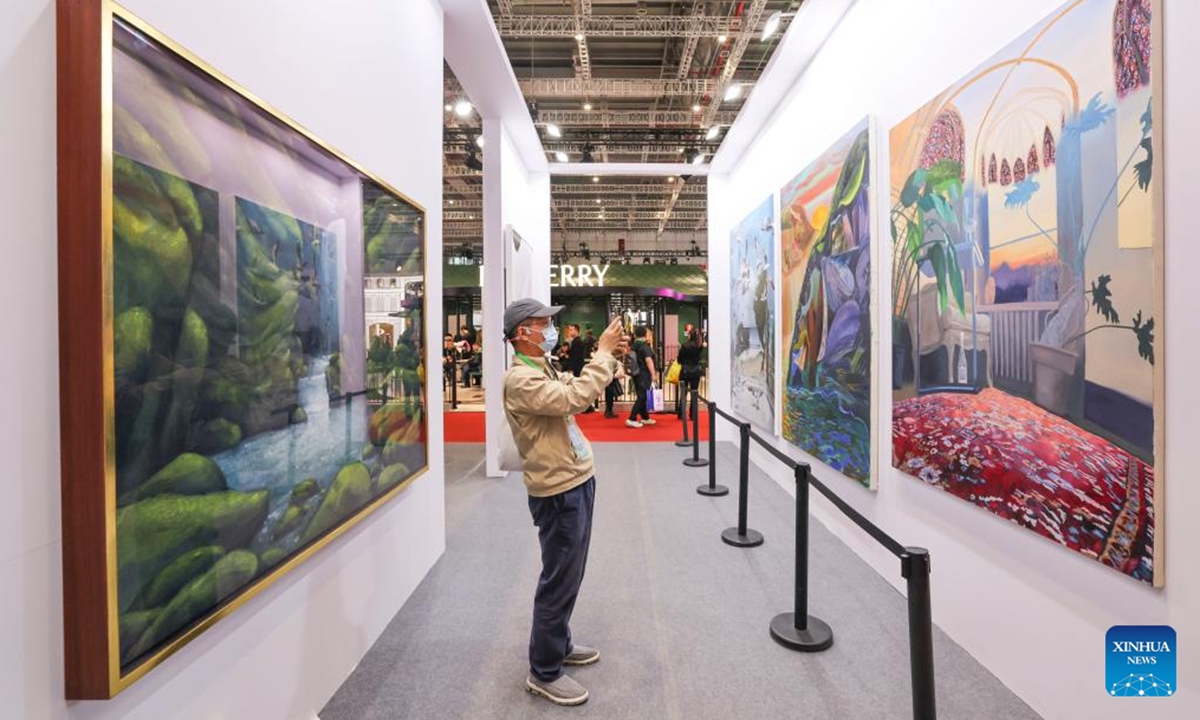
[1104,625,1178,697]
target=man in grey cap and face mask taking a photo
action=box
[504,299,628,706]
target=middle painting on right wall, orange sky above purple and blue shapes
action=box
[779,120,875,487]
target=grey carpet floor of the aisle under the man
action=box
[320,443,1037,720]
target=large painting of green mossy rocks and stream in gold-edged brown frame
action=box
[59,0,427,698]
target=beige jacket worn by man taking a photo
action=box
[504,350,619,498]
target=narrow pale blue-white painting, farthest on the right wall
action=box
[730,197,775,433]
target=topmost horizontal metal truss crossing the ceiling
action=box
[496,14,742,37]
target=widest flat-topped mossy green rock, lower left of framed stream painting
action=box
[116,490,268,611]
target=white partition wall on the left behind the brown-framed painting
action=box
[0,0,445,720]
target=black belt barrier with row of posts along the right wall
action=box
[680,393,937,720]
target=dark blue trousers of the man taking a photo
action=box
[529,478,596,683]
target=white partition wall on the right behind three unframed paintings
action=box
[709,0,1200,718]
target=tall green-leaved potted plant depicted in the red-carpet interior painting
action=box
[892,160,966,389]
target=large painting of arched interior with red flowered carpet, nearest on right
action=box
[889,0,1163,586]
